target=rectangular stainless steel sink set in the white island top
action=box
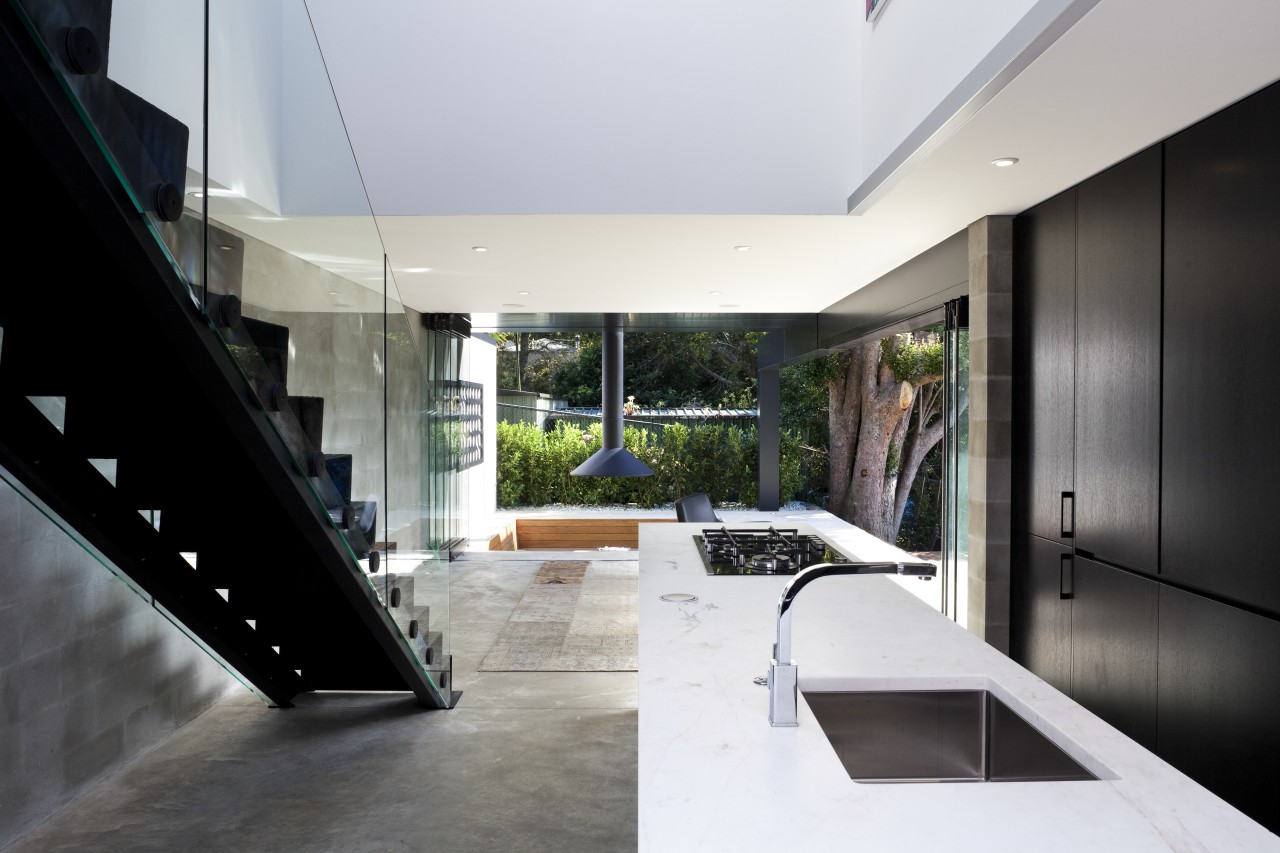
[804,690,1098,783]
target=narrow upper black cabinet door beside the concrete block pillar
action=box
[1014,191,1075,543]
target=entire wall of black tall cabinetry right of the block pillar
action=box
[1011,85,1280,831]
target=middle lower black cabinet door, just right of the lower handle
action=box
[1071,556,1160,749]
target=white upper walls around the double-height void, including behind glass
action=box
[110,0,1096,215]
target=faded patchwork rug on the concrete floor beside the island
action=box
[480,560,640,672]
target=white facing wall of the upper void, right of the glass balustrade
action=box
[299,0,860,215]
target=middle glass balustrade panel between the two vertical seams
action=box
[197,0,387,562]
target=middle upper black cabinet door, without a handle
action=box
[1075,146,1162,573]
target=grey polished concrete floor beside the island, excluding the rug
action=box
[5,552,636,853]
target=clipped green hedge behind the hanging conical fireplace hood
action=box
[498,421,804,507]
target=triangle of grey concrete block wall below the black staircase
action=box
[0,471,244,848]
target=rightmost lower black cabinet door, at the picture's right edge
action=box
[1156,587,1280,833]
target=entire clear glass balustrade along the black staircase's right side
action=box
[9,0,462,701]
